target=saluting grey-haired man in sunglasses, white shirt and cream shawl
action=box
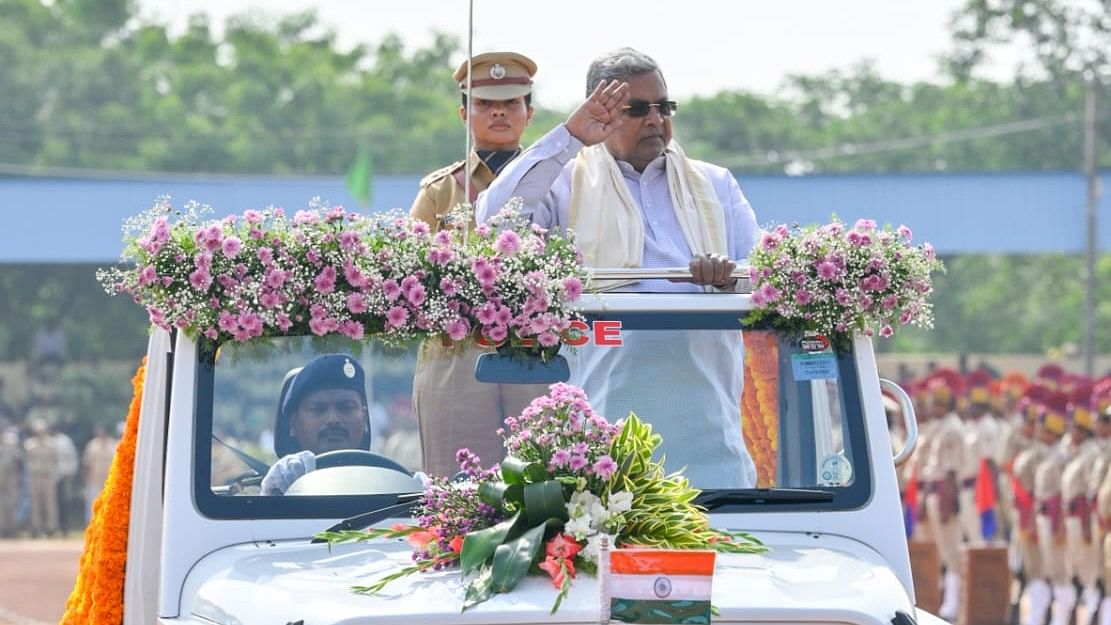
[477,48,760,488]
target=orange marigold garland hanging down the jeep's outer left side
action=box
[60,357,147,625]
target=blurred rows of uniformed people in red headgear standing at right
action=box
[890,364,1111,625]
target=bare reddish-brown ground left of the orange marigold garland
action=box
[0,535,83,625]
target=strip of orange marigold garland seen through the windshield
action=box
[741,330,779,488]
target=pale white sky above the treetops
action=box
[139,0,1005,107]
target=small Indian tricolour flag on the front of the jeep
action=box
[601,548,715,623]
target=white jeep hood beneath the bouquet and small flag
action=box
[181,532,913,625]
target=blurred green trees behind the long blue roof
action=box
[0,0,1111,174]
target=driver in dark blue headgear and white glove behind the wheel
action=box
[262,354,370,495]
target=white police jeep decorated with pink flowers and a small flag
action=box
[119,276,941,625]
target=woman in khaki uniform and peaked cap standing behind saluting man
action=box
[409,52,548,476]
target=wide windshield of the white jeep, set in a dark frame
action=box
[196,294,871,517]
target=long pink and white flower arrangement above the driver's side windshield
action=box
[97,196,584,354]
